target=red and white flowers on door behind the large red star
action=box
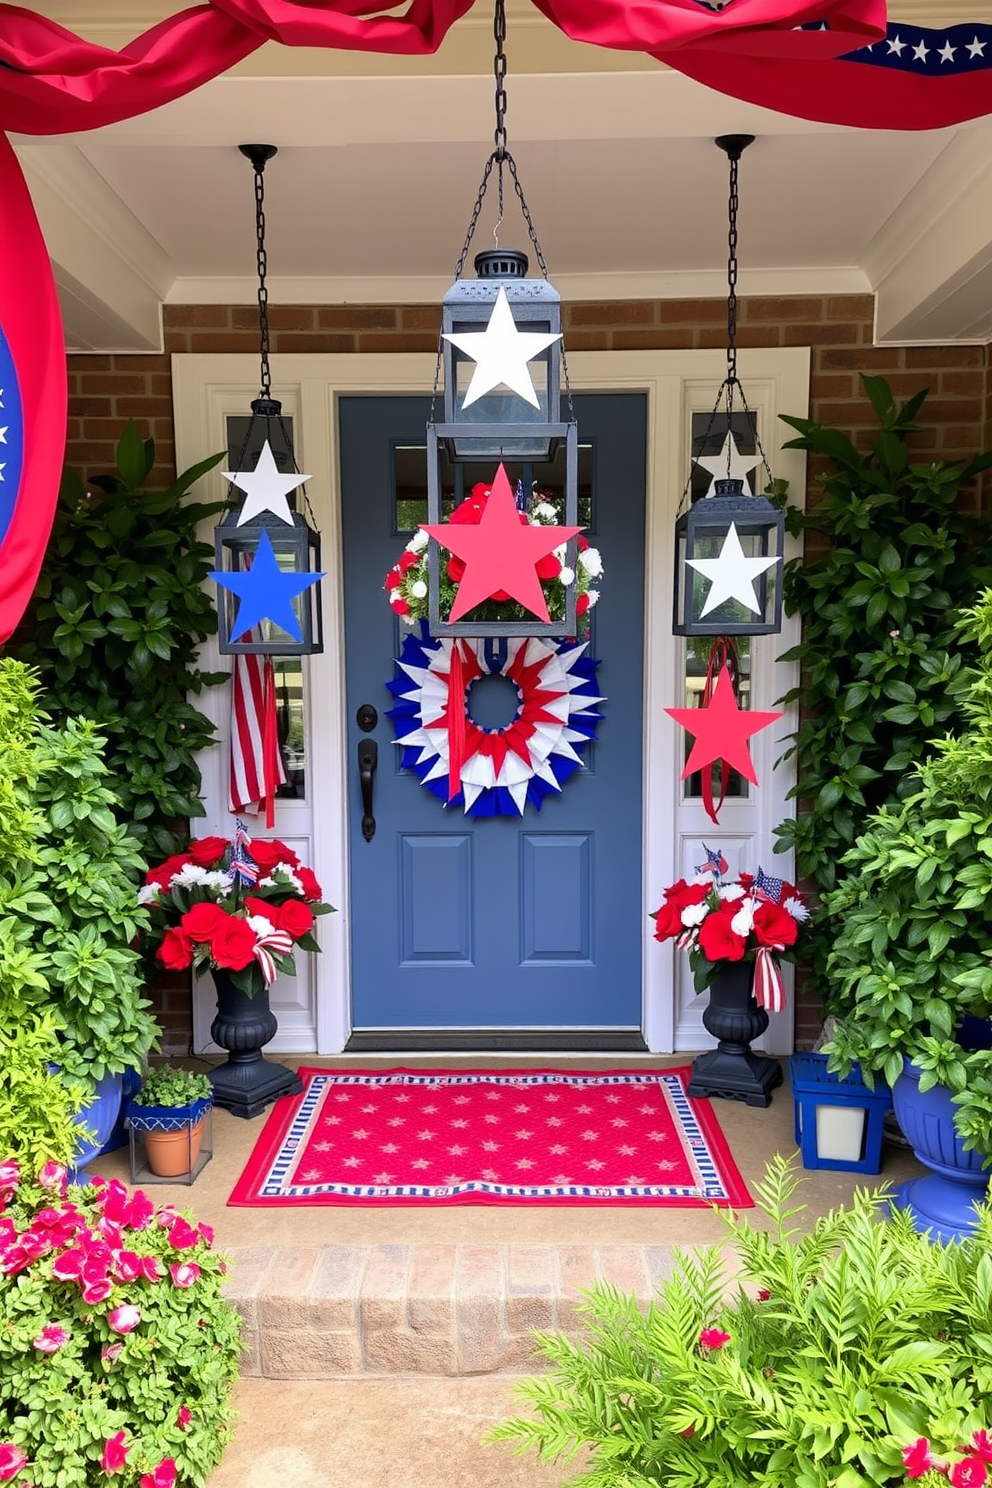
[384,484,602,625]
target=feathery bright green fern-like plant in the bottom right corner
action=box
[491,1158,992,1488]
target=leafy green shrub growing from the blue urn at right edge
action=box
[825,589,992,1161]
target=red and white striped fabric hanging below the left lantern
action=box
[231,653,286,827]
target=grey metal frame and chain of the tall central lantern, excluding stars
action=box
[427,0,579,638]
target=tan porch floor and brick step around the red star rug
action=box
[92,1055,922,1488]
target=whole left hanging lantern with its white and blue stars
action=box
[211,144,323,656]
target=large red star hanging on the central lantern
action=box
[424,466,582,623]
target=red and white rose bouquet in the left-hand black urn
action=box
[138,836,332,995]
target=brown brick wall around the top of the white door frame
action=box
[67,295,992,1046]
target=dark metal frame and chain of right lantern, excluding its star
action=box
[672,134,785,635]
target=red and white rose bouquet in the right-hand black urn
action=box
[651,854,809,1012]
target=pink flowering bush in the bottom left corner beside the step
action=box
[0,1162,239,1488]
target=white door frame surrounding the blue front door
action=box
[173,347,809,1054]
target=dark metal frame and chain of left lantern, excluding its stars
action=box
[214,144,324,656]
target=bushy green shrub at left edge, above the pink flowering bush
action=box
[0,658,158,1091]
